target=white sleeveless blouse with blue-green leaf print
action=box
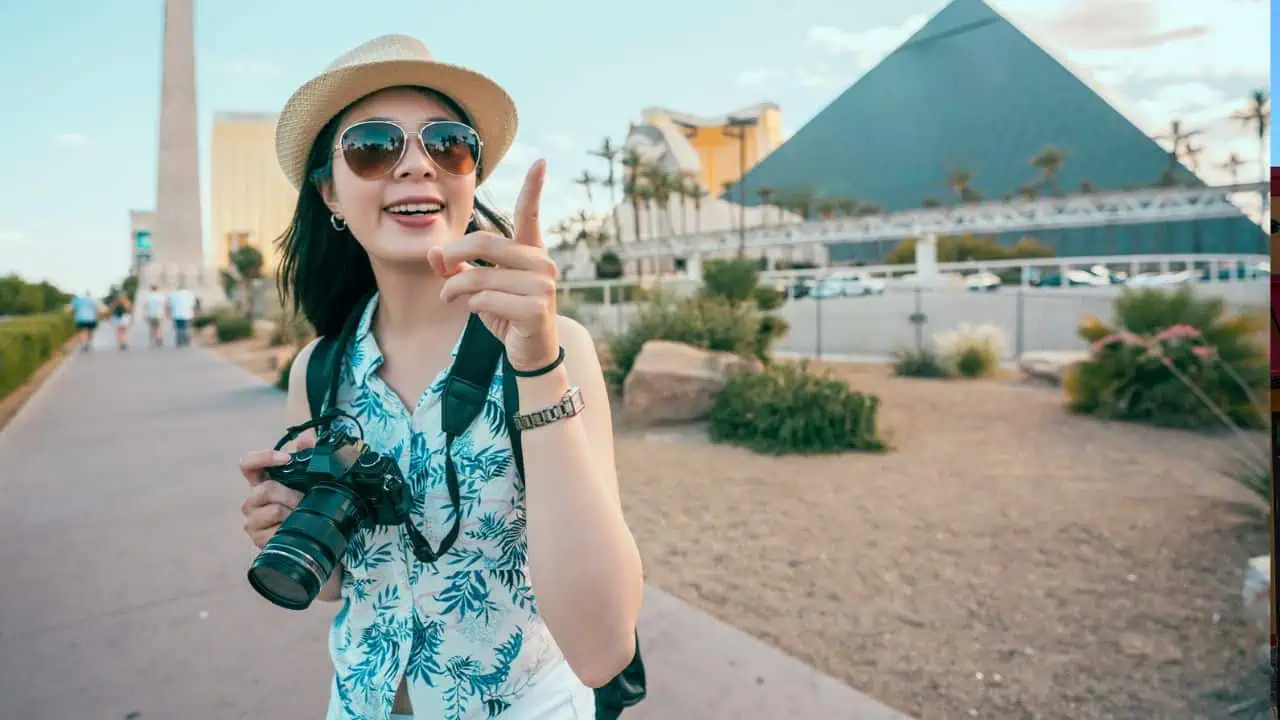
[328,295,563,720]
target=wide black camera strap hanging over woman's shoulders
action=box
[304,295,503,562]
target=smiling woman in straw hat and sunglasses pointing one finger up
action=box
[241,36,643,720]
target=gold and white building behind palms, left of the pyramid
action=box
[641,102,782,195]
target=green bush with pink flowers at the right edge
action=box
[1064,287,1268,428]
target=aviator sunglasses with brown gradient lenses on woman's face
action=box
[334,120,481,179]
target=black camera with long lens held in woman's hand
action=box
[248,418,412,610]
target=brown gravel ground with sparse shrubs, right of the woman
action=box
[617,366,1266,720]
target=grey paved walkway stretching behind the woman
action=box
[0,322,904,720]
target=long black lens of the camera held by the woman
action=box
[248,483,364,610]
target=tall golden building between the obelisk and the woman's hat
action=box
[210,113,298,273]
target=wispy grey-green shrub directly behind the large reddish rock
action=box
[605,293,760,388]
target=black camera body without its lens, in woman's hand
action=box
[266,428,412,527]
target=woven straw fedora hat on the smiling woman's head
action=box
[275,35,517,190]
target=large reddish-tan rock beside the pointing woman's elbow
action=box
[622,340,760,425]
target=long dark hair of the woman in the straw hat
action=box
[275,87,512,337]
